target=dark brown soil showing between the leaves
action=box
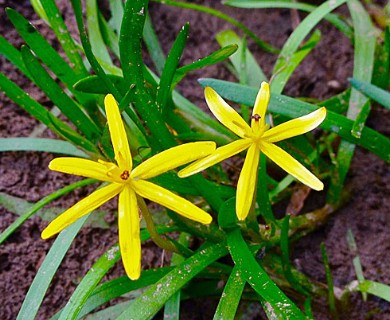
[0,0,390,320]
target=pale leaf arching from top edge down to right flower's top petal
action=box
[271,0,347,93]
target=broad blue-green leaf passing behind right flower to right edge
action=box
[199,79,390,162]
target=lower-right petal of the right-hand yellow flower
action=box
[260,142,324,191]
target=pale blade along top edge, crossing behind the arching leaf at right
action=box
[224,0,353,39]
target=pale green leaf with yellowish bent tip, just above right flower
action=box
[216,30,267,88]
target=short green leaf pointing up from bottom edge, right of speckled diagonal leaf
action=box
[213,265,246,320]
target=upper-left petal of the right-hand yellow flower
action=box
[204,87,252,138]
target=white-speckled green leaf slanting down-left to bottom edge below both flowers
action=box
[117,244,227,320]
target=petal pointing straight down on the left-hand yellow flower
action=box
[118,186,141,280]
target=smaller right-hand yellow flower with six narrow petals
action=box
[179,82,326,220]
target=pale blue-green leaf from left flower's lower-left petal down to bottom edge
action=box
[17,215,88,320]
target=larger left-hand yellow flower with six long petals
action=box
[42,95,215,280]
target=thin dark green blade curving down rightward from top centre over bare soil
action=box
[153,0,278,53]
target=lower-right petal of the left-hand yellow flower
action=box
[133,180,212,224]
